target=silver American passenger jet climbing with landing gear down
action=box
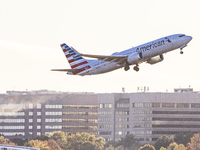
[52,34,192,76]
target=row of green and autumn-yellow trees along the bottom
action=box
[0,131,200,150]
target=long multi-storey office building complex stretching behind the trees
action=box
[0,89,200,144]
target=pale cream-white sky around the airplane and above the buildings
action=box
[0,0,200,93]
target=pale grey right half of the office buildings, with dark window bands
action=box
[98,92,200,144]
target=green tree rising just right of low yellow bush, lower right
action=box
[154,135,174,150]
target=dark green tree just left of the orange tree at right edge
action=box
[174,131,194,146]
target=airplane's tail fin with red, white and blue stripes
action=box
[60,43,91,75]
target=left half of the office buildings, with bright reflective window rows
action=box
[0,93,98,139]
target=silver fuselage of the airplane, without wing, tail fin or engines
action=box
[79,34,192,76]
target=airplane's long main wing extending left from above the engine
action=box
[80,54,127,63]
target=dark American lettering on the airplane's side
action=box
[136,40,165,52]
